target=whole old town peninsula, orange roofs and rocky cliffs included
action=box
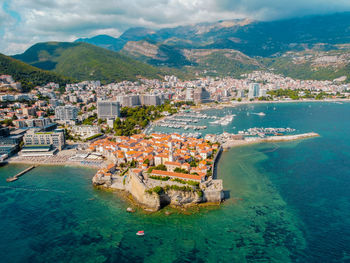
[90,133,224,210]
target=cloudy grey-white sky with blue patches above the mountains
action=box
[0,0,350,55]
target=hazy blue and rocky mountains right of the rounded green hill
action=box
[77,12,350,79]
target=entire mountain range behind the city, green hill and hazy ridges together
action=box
[5,13,350,85]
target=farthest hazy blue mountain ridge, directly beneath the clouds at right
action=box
[75,12,350,57]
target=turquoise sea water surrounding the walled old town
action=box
[0,103,350,262]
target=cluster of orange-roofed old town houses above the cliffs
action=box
[90,133,219,181]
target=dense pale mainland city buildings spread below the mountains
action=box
[0,71,350,163]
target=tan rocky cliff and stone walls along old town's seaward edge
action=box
[92,171,224,211]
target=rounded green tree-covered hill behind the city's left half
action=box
[14,42,165,83]
